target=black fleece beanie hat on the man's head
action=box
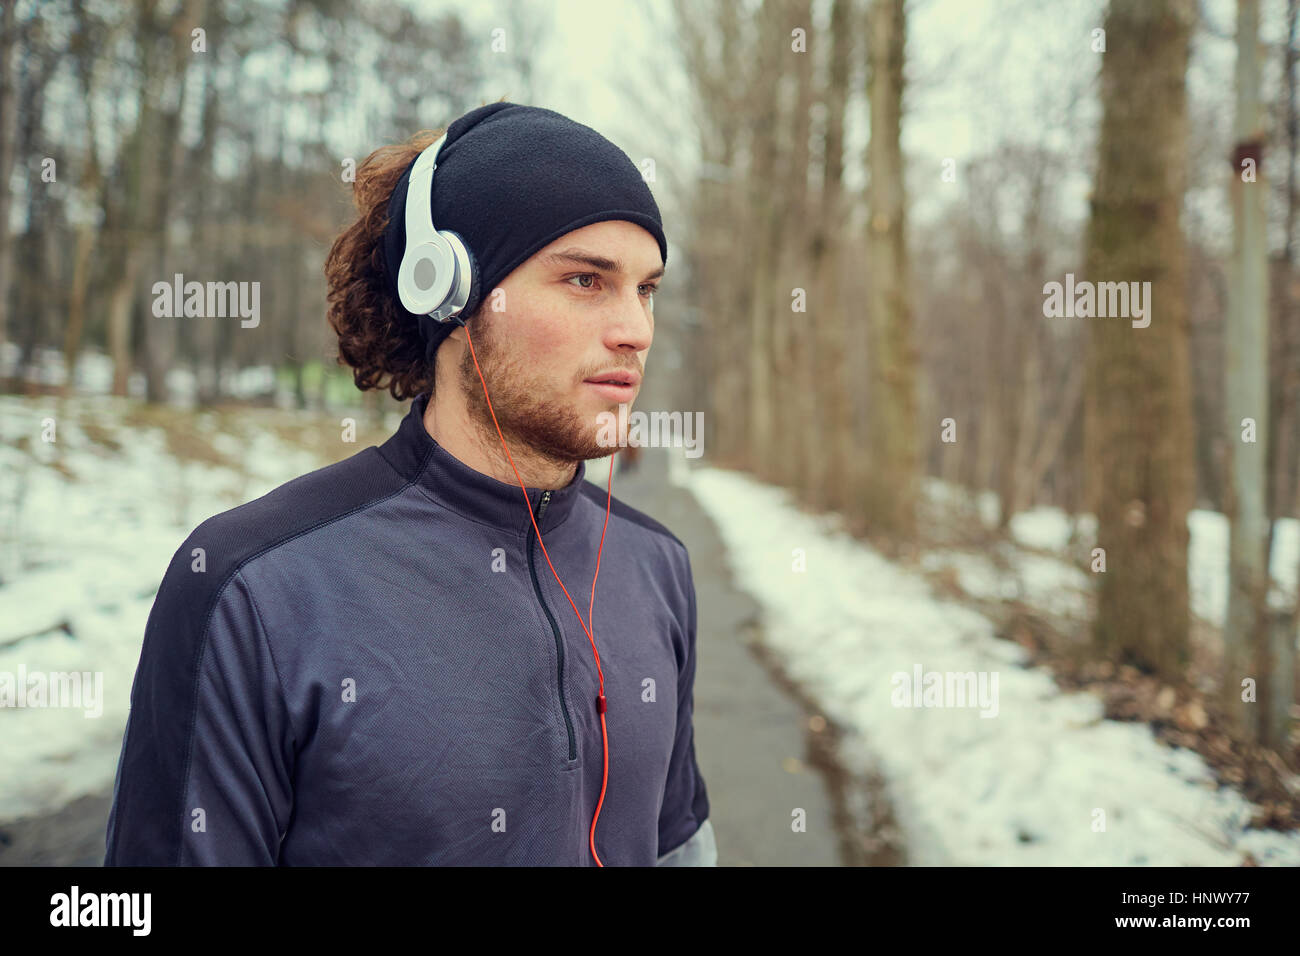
[384,103,668,364]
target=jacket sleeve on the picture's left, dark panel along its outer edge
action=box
[104,561,295,866]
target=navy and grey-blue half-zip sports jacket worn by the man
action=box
[104,395,716,866]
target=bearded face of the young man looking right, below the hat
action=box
[454,220,663,462]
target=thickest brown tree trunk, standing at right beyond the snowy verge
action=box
[1069,0,1196,680]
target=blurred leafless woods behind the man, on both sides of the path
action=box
[0,0,1300,769]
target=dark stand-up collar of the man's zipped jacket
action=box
[380,393,586,536]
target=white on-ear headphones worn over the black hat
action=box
[398,133,475,325]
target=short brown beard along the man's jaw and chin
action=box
[460,319,618,464]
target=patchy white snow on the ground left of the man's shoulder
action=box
[0,395,340,821]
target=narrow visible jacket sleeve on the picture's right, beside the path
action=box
[655,554,718,866]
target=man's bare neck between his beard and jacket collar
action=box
[424,388,577,489]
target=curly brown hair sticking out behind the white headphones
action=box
[325,129,486,402]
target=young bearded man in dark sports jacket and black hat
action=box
[105,103,716,866]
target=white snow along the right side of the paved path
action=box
[672,468,1300,866]
